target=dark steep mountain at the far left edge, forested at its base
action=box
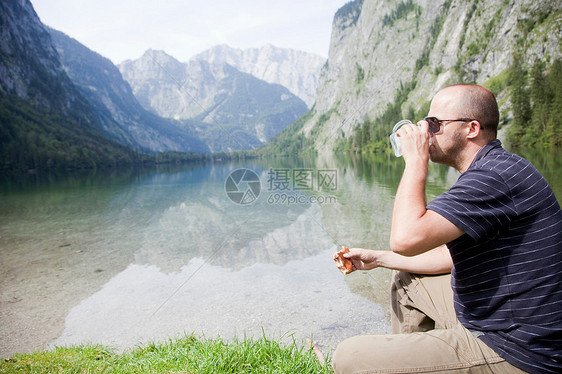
[0,0,137,170]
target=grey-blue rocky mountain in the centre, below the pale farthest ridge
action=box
[119,50,307,151]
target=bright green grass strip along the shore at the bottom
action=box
[0,335,333,374]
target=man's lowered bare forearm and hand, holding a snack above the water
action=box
[344,246,453,274]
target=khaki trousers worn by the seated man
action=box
[332,272,524,373]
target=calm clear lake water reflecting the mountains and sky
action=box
[0,148,562,357]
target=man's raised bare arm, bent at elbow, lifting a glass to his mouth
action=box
[390,121,464,256]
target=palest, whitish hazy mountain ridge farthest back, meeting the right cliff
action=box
[193,44,326,108]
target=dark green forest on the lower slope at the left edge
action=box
[0,96,147,172]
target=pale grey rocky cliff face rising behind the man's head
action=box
[302,0,562,151]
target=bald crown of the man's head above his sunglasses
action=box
[434,84,500,139]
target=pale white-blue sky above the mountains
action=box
[31,0,349,64]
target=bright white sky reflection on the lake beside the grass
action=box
[54,251,388,348]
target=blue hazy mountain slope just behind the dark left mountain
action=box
[49,29,209,153]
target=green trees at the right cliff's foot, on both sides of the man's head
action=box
[346,54,562,153]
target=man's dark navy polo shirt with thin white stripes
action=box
[427,140,562,373]
